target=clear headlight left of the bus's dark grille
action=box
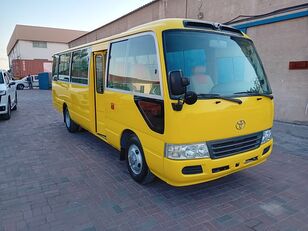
[165,143,210,160]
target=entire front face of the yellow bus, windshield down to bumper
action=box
[163,21,273,185]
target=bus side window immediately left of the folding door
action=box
[71,49,89,84]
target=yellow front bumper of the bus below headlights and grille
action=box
[161,139,273,186]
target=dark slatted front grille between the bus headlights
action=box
[207,132,262,159]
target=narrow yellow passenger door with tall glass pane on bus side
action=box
[94,50,107,138]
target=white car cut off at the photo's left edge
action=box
[0,70,17,120]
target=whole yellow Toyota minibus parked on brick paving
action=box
[52,19,274,186]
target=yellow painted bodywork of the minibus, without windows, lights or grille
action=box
[52,19,274,186]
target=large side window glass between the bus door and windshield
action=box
[108,35,161,95]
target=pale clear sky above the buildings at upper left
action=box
[0,0,152,69]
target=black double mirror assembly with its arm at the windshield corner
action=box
[168,70,198,111]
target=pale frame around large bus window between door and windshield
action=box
[104,31,164,100]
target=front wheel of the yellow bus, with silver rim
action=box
[125,135,155,184]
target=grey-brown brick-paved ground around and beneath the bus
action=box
[0,90,308,231]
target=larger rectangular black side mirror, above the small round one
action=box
[169,70,190,96]
